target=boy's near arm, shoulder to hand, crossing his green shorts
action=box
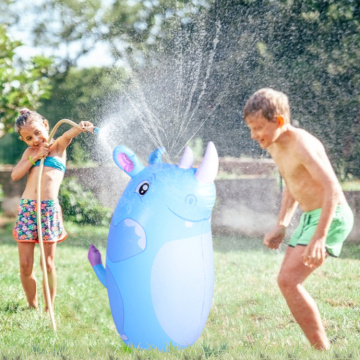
[303,141,342,268]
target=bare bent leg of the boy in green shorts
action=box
[278,246,330,350]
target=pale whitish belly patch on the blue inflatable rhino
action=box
[151,232,214,346]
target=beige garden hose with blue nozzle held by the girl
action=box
[36,119,100,332]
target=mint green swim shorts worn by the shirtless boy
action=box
[289,204,354,257]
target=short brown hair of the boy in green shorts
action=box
[244,88,290,123]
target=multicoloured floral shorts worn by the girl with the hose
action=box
[13,199,67,243]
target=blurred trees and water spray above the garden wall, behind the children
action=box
[0,0,360,172]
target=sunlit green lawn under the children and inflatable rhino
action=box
[0,224,360,360]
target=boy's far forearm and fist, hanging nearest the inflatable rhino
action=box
[264,187,298,249]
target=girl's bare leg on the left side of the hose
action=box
[18,242,38,309]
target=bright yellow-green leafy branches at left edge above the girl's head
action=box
[0,25,52,133]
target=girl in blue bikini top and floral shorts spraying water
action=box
[11,109,94,311]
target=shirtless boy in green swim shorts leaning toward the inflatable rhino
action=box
[244,88,354,350]
